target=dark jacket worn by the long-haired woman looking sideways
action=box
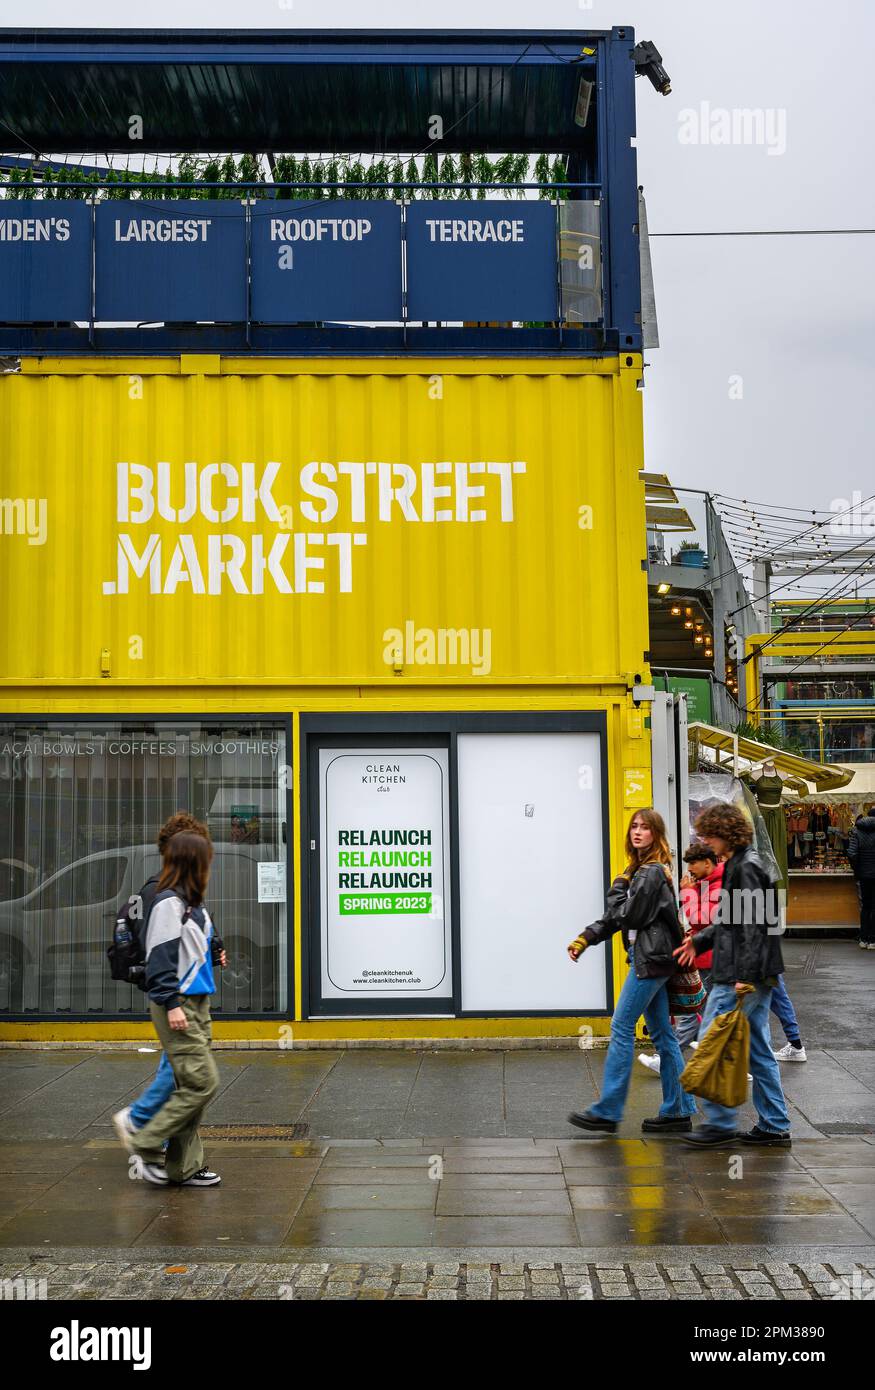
[583,863,683,980]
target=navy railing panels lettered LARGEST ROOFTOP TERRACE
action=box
[0,177,608,352]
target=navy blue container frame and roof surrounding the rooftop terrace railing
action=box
[0,26,668,354]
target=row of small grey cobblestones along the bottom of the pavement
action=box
[0,1259,875,1302]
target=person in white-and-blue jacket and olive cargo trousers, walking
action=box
[131,831,221,1187]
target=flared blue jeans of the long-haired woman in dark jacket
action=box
[587,970,695,1120]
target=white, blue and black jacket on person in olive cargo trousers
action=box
[146,890,216,1009]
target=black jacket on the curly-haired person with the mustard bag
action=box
[696,845,783,984]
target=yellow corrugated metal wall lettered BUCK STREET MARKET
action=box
[0,357,647,685]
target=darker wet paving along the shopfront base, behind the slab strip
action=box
[0,940,875,1141]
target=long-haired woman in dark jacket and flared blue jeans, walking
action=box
[568,808,696,1134]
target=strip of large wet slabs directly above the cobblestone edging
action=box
[0,1137,875,1262]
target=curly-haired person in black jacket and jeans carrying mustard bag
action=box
[675,802,792,1148]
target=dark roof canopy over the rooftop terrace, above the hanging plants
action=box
[0,29,612,154]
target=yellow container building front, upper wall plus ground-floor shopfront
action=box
[0,354,650,1045]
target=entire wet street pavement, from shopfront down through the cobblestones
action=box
[0,941,875,1301]
